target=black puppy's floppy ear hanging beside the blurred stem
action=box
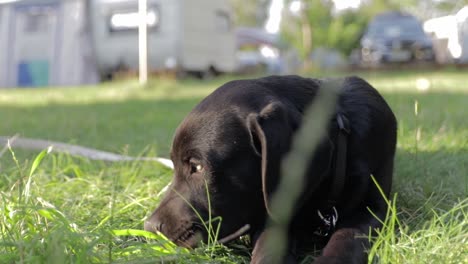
[247,102,300,215]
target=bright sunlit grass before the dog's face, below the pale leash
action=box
[0,151,247,263]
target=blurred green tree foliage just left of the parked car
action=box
[282,0,402,58]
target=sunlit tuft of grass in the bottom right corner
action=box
[369,197,468,264]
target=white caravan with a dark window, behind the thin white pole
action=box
[90,0,236,76]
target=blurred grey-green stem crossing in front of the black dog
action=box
[267,81,341,262]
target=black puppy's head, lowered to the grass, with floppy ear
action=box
[145,80,330,247]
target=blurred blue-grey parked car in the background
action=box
[360,11,434,64]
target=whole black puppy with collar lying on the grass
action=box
[145,76,397,263]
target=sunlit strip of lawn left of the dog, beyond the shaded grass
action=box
[0,79,222,106]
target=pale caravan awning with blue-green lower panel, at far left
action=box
[0,0,98,87]
